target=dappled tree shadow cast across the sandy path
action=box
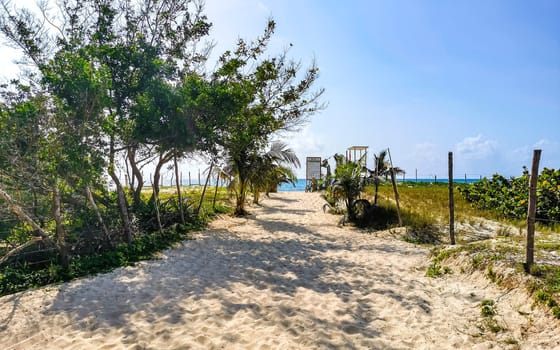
[34,198,430,349]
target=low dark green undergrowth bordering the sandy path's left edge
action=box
[0,190,226,296]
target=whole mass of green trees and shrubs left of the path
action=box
[0,0,324,290]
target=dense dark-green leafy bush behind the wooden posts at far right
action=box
[459,168,560,224]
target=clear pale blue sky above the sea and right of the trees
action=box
[0,0,560,178]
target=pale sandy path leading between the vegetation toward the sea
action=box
[0,193,560,349]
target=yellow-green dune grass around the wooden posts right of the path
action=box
[365,183,560,319]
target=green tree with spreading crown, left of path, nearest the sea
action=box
[210,20,324,215]
